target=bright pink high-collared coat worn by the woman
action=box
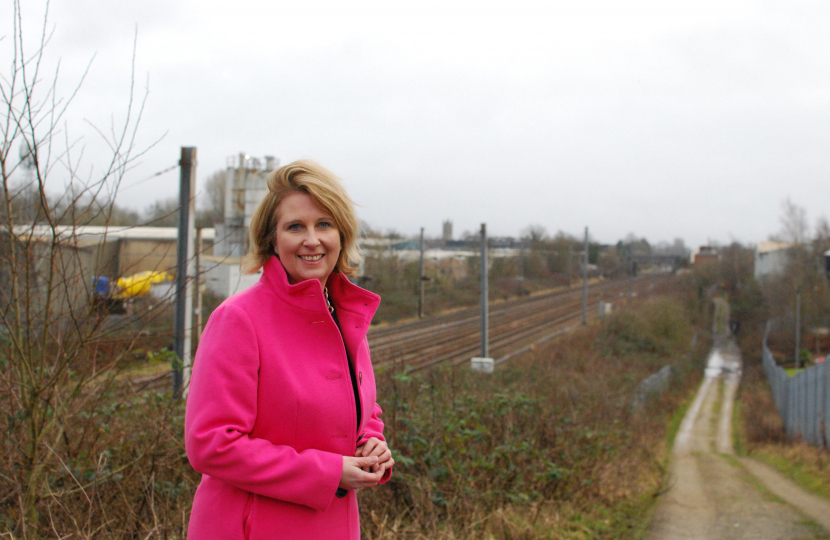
[185,257,390,540]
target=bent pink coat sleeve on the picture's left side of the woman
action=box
[185,305,343,510]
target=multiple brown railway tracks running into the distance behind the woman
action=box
[368,276,670,372]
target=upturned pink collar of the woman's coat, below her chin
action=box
[260,256,380,326]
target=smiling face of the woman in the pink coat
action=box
[274,191,340,287]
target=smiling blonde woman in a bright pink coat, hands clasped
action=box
[185,161,394,540]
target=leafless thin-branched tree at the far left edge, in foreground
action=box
[0,0,196,539]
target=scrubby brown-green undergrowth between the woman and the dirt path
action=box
[361,299,707,540]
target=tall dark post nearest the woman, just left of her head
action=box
[173,147,196,396]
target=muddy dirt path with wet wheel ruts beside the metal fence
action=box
[646,300,830,540]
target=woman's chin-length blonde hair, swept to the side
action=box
[242,159,360,276]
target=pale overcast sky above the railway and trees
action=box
[6,0,830,245]
